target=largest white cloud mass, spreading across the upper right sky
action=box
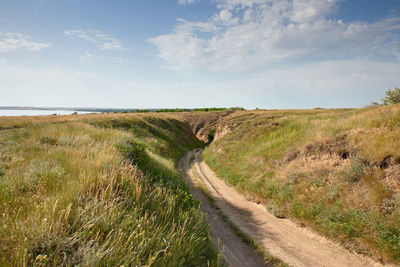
[149,0,400,71]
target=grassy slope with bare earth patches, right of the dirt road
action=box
[204,105,400,263]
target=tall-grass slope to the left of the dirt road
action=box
[0,114,219,266]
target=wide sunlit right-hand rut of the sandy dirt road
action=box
[183,150,390,267]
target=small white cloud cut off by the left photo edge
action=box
[0,32,51,52]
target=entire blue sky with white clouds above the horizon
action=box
[0,0,400,109]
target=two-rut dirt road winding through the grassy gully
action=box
[182,150,388,267]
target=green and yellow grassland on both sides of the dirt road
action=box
[0,105,400,266]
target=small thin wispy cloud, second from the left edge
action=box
[64,30,125,51]
